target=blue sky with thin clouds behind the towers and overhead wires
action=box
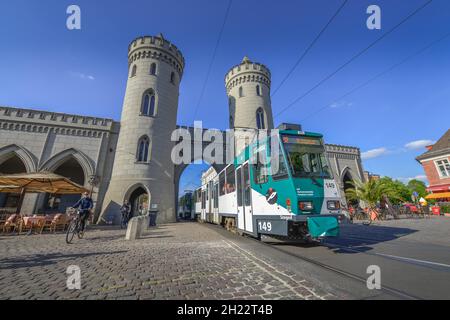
[0,0,450,190]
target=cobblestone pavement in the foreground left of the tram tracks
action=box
[0,223,337,299]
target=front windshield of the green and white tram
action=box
[282,135,330,178]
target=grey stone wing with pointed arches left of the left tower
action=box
[0,107,119,219]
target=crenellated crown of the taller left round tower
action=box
[128,33,185,74]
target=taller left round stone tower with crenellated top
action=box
[102,34,184,223]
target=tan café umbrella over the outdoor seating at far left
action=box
[0,171,89,213]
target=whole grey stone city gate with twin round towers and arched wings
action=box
[0,34,364,223]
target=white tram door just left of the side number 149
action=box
[236,162,253,232]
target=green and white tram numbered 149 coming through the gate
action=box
[195,125,341,240]
